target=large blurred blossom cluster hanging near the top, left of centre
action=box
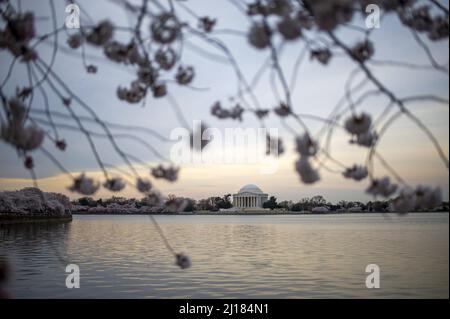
[67,13,199,104]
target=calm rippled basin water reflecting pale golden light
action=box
[0,213,449,298]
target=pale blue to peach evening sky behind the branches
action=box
[0,0,449,201]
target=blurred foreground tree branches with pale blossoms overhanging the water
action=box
[0,0,449,268]
